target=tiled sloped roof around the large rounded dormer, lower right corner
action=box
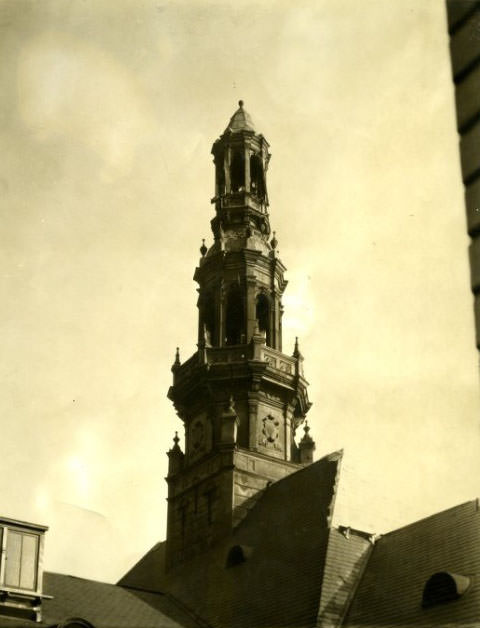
[344,501,480,628]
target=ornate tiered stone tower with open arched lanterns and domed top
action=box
[167,101,315,568]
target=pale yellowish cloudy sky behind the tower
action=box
[0,0,480,582]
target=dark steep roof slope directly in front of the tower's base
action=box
[163,454,341,628]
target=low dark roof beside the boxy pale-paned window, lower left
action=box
[0,572,199,628]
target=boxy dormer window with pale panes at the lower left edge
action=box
[0,518,48,620]
